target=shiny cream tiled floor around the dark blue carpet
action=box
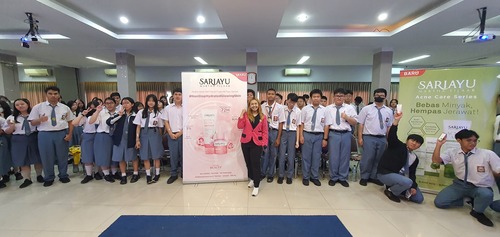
[0,172,500,237]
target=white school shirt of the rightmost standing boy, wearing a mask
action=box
[358,103,394,136]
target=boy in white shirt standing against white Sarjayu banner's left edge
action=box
[161,88,183,184]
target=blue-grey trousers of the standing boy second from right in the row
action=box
[328,131,352,181]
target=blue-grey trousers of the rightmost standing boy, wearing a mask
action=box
[359,135,387,179]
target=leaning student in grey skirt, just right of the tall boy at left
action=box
[73,101,99,184]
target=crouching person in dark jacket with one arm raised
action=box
[377,113,424,203]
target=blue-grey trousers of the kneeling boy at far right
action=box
[434,179,493,213]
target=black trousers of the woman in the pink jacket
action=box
[241,140,262,188]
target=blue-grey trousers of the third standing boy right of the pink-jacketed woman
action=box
[302,131,323,179]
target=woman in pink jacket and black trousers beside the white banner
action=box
[238,98,268,197]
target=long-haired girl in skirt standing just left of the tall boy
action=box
[3,99,44,188]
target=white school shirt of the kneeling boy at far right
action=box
[441,147,500,187]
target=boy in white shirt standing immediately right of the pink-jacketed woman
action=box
[261,88,285,183]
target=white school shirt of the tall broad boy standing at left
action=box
[28,101,75,131]
